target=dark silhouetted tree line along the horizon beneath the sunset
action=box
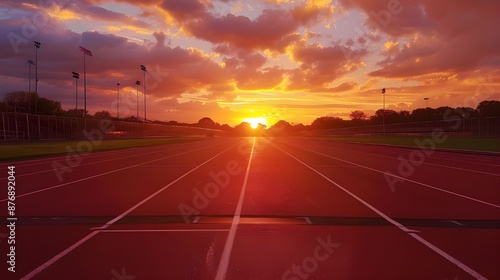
[0,91,500,135]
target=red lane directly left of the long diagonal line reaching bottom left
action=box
[2,140,241,279]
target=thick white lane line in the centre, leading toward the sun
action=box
[215,137,255,280]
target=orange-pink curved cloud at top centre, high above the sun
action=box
[161,0,333,52]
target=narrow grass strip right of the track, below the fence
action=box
[320,136,500,152]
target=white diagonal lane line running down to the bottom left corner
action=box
[21,142,237,280]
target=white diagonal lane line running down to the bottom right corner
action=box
[271,144,486,279]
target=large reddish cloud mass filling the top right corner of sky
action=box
[341,0,500,78]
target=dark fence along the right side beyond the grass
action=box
[304,117,500,136]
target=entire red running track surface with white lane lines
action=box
[0,138,500,280]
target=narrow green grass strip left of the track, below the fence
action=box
[0,137,204,162]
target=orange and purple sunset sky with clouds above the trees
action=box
[0,0,500,125]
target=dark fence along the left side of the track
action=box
[0,112,225,141]
